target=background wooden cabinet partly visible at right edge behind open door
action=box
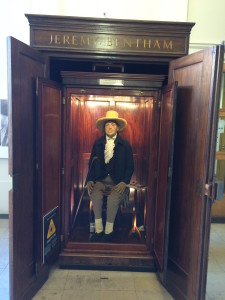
[212,65,225,223]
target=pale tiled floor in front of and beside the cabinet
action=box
[0,219,225,300]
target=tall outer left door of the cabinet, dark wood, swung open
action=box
[7,38,48,300]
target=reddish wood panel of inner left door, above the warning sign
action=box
[39,86,61,214]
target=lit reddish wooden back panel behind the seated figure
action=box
[71,94,153,240]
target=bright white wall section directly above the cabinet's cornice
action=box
[56,0,188,21]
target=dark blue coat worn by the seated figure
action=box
[87,133,134,184]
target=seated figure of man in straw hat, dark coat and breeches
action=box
[87,110,134,242]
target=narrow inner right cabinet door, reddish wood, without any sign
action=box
[153,82,177,282]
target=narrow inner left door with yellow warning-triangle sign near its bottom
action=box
[35,77,62,275]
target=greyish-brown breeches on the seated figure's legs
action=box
[90,176,124,223]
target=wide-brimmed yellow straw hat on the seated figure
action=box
[96,110,127,132]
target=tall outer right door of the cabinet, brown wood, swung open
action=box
[165,46,224,300]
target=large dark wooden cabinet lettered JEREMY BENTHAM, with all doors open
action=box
[8,15,224,300]
